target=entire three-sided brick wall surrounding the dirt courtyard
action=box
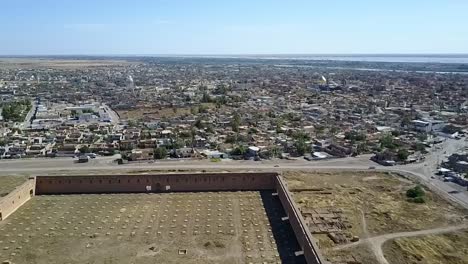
[0,173,326,264]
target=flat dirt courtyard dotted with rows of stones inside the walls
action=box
[0,192,304,264]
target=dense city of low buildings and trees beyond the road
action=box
[0,58,468,173]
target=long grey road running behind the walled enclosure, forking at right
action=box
[0,139,468,208]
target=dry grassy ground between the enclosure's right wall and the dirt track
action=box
[283,171,468,263]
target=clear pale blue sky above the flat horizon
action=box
[0,0,468,55]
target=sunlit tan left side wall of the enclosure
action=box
[0,178,35,221]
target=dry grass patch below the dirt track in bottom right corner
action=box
[383,230,468,264]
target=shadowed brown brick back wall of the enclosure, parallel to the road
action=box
[36,173,277,194]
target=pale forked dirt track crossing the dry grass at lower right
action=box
[334,223,468,264]
